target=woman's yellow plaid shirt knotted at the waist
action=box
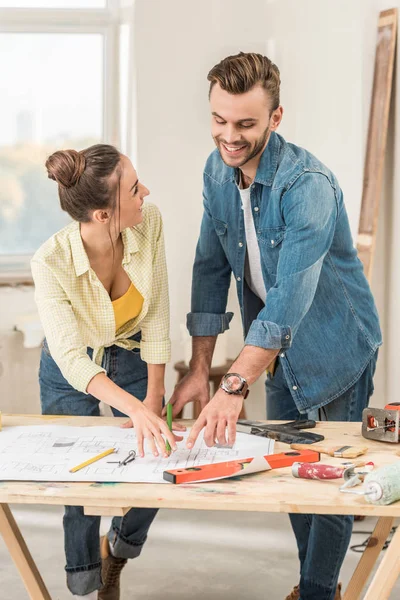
[31,204,171,393]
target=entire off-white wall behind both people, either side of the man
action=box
[0,0,392,417]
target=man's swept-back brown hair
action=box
[207,52,281,110]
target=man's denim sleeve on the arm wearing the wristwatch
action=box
[245,173,338,349]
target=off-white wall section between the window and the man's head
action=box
[135,0,266,416]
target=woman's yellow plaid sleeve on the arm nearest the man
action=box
[140,207,171,365]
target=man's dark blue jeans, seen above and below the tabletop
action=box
[265,353,378,600]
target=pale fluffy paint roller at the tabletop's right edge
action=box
[363,461,400,504]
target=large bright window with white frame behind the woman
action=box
[0,0,132,282]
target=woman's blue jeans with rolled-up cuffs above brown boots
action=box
[39,334,157,596]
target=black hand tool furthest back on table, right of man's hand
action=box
[236,419,325,444]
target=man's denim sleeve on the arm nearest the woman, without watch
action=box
[187,190,233,336]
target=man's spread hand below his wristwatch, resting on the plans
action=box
[186,389,244,448]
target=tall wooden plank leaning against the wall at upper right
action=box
[357,8,397,281]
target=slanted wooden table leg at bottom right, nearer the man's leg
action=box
[343,517,394,600]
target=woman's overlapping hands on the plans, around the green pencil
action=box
[122,398,186,458]
